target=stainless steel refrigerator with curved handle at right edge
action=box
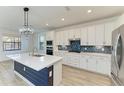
[111,25,124,85]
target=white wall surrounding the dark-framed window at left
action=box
[0,28,32,62]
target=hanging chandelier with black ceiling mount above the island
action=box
[19,7,34,36]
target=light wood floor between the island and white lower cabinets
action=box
[60,65,112,86]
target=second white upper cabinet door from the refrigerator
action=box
[95,24,104,45]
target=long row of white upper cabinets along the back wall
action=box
[54,22,114,46]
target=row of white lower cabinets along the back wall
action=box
[55,52,111,75]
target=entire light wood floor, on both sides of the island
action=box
[0,61,111,86]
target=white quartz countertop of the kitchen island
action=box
[7,53,62,71]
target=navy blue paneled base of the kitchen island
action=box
[14,61,53,86]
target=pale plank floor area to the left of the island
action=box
[0,61,28,86]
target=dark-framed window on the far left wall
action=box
[3,36,21,51]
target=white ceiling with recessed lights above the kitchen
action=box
[0,6,124,31]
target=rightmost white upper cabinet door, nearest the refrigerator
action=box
[105,22,114,45]
